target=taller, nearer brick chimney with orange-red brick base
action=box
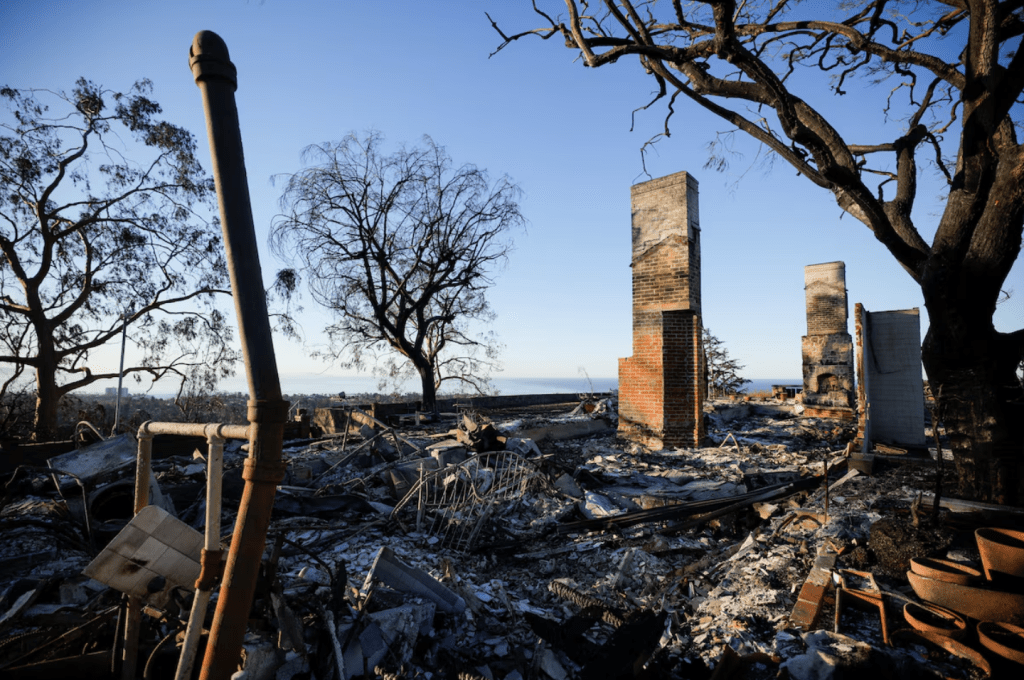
[618,172,705,448]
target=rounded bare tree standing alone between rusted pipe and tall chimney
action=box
[271,132,523,410]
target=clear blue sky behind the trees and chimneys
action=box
[0,0,1024,391]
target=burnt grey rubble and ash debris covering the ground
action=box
[0,396,1024,680]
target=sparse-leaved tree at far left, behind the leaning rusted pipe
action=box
[0,79,236,438]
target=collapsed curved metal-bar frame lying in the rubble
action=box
[390,451,540,552]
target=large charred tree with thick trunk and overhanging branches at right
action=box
[492,0,1024,503]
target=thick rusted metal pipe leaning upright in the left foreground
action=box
[188,31,288,680]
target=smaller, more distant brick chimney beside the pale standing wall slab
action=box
[802,262,855,420]
